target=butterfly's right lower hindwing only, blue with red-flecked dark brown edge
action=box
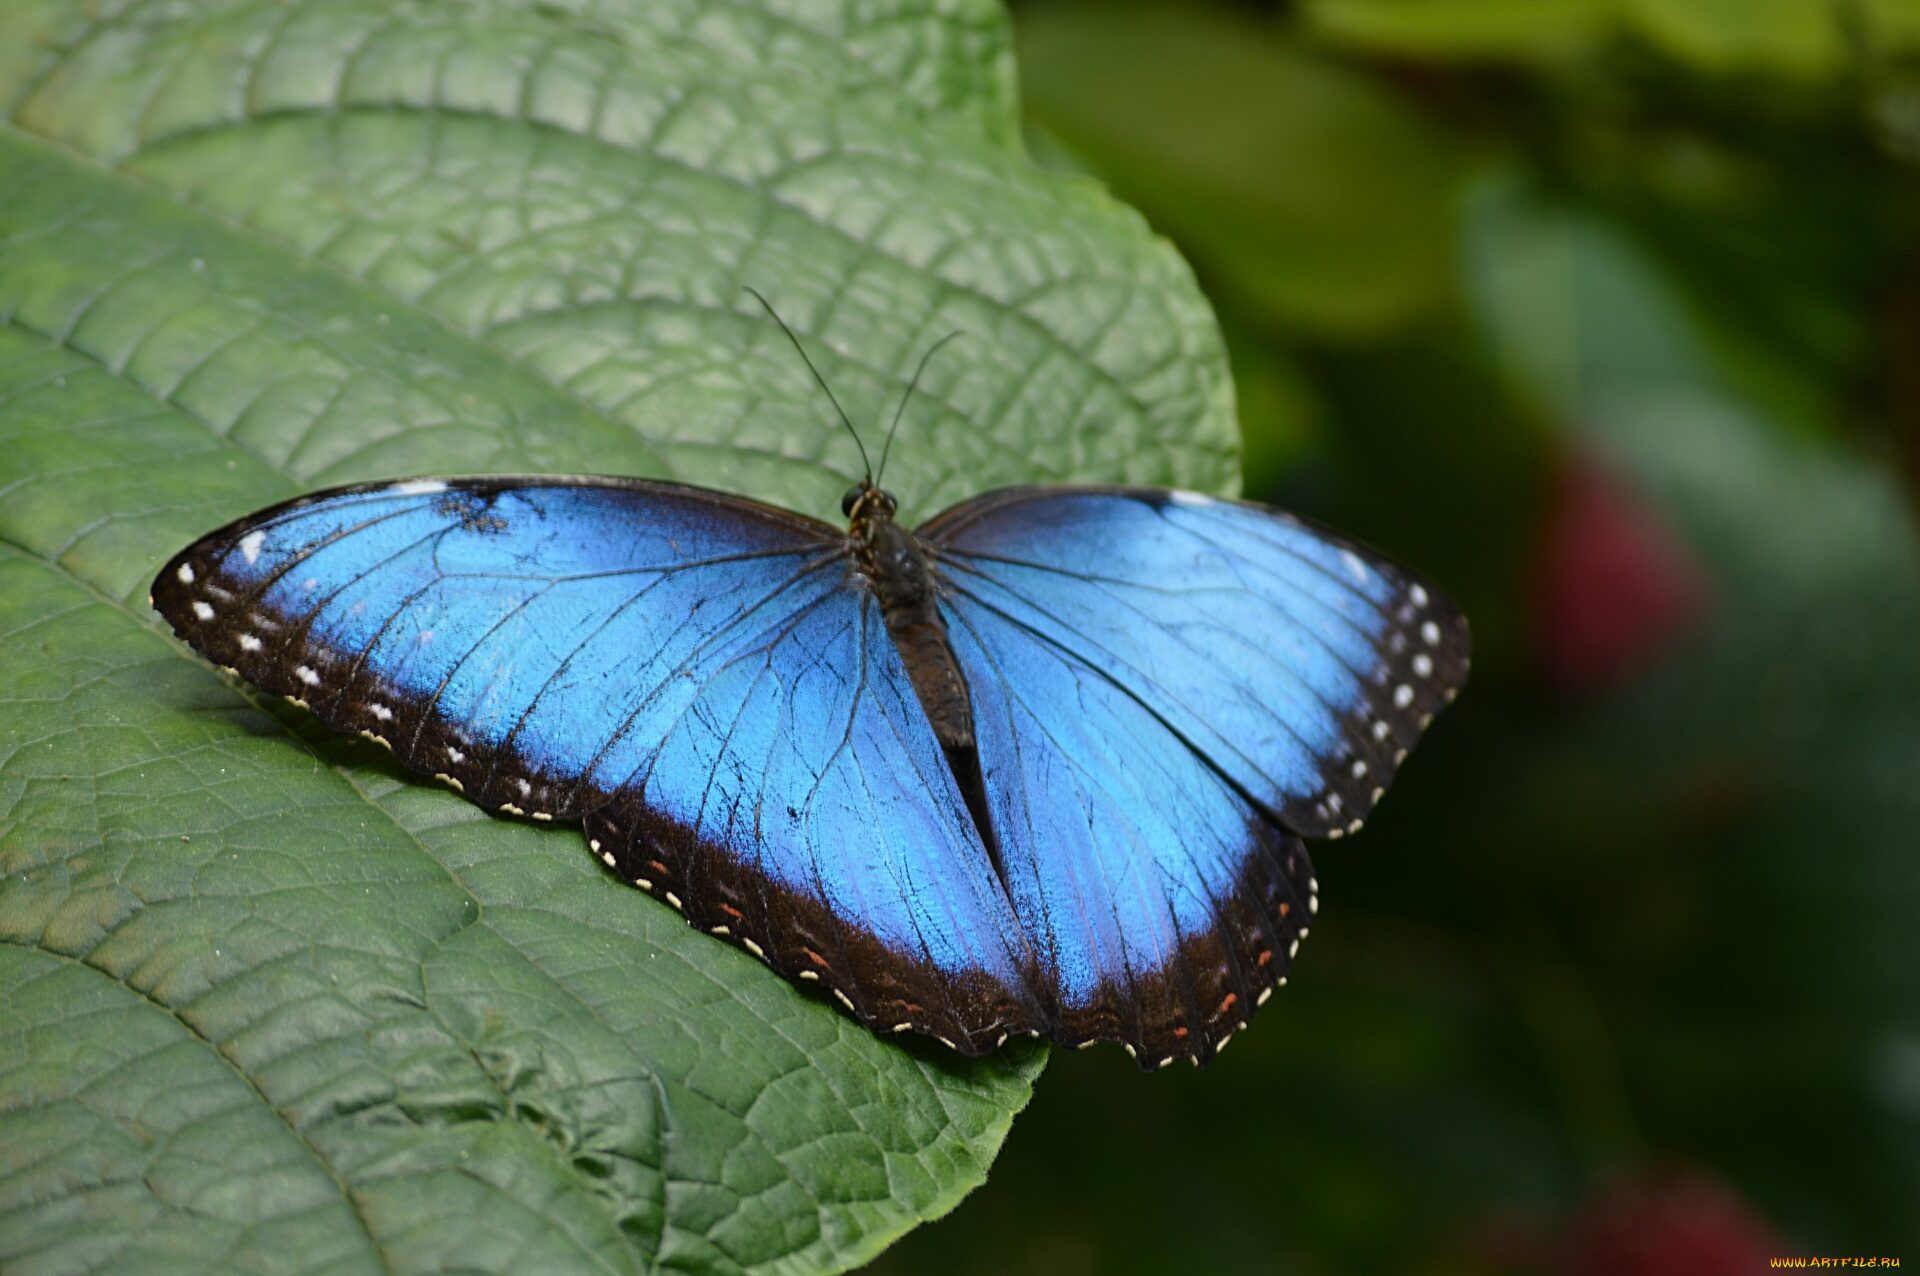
[948,595,1313,1067]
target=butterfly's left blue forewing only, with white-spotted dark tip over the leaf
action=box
[154,478,845,819]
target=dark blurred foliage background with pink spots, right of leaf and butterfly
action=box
[872,0,1920,1276]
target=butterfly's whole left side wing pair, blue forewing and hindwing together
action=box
[154,478,1043,1053]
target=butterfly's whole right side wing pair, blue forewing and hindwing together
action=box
[920,487,1469,1063]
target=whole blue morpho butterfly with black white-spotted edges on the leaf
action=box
[154,307,1469,1067]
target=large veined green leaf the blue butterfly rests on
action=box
[0,0,1238,1272]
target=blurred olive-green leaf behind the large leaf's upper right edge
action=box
[1020,6,1459,340]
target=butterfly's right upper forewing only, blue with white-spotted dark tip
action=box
[920,487,1471,837]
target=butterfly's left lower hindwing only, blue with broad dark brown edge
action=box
[588,589,1046,1053]
